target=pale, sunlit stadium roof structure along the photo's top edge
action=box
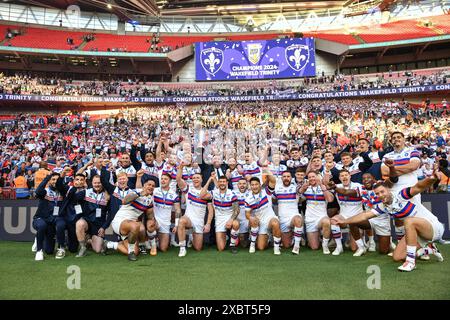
[8,0,396,17]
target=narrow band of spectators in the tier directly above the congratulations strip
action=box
[0,70,450,98]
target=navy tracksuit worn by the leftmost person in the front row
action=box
[33,175,66,254]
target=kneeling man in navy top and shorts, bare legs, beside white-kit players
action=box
[74,175,111,258]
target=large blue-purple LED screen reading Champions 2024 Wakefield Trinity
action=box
[195,38,316,81]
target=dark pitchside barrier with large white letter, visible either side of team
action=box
[0,194,450,241]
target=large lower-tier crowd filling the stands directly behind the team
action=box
[0,99,450,197]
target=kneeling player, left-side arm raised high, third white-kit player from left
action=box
[175,162,214,257]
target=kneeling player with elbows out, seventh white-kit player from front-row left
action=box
[298,171,334,254]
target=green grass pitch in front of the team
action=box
[0,242,450,300]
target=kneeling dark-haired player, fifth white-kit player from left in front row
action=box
[245,170,281,255]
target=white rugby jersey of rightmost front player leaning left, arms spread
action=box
[372,187,438,224]
